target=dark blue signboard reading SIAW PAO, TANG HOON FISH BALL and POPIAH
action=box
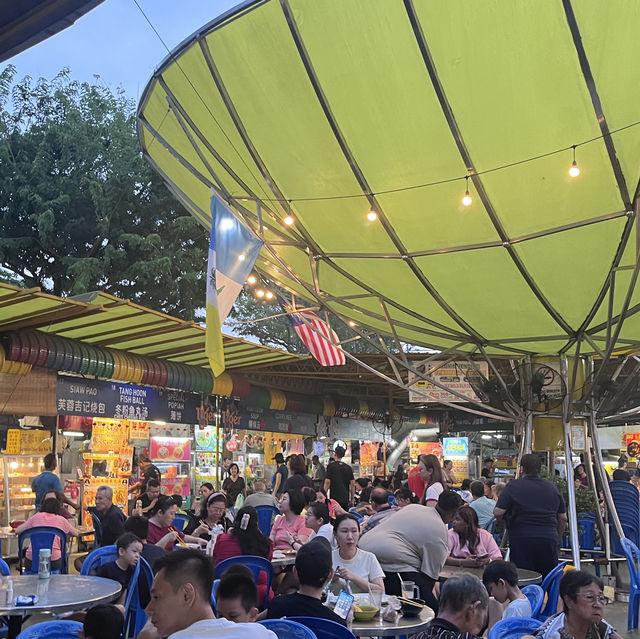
[56,375,200,424]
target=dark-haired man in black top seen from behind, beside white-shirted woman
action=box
[260,537,346,626]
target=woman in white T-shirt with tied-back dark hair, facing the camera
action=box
[331,513,384,594]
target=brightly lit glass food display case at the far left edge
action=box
[0,455,43,526]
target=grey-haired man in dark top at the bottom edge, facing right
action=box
[412,574,489,639]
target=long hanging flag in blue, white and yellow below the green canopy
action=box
[205,195,262,377]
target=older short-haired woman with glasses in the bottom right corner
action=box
[534,570,621,639]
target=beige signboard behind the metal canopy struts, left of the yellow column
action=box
[408,361,489,404]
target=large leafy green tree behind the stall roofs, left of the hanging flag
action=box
[0,66,207,319]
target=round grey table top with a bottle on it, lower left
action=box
[0,575,120,617]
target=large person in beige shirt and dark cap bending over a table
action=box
[360,490,464,614]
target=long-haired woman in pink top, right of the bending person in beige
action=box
[445,506,502,568]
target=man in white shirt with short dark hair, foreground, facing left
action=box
[146,550,276,639]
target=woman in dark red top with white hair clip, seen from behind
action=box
[213,506,273,607]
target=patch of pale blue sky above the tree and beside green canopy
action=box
[4,0,239,101]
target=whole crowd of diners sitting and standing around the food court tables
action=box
[23,448,616,639]
